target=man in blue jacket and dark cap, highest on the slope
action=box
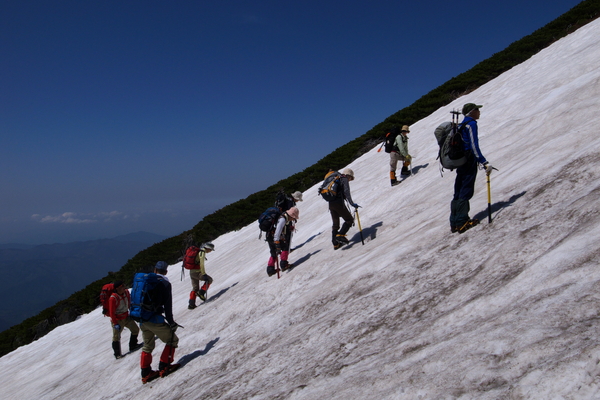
[450,103,492,233]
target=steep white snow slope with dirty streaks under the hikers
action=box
[0,20,600,399]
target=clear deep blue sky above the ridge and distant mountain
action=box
[0,0,579,244]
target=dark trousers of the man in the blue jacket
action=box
[450,155,477,227]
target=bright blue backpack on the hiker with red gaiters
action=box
[129,272,163,322]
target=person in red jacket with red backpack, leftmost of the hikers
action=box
[108,281,142,359]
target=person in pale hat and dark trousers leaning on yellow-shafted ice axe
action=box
[325,168,360,250]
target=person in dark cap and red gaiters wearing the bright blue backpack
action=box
[140,261,180,383]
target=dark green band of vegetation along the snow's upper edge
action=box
[0,0,600,356]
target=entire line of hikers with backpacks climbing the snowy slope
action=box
[100,103,495,383]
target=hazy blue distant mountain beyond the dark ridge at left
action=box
[0,232,166,331]
